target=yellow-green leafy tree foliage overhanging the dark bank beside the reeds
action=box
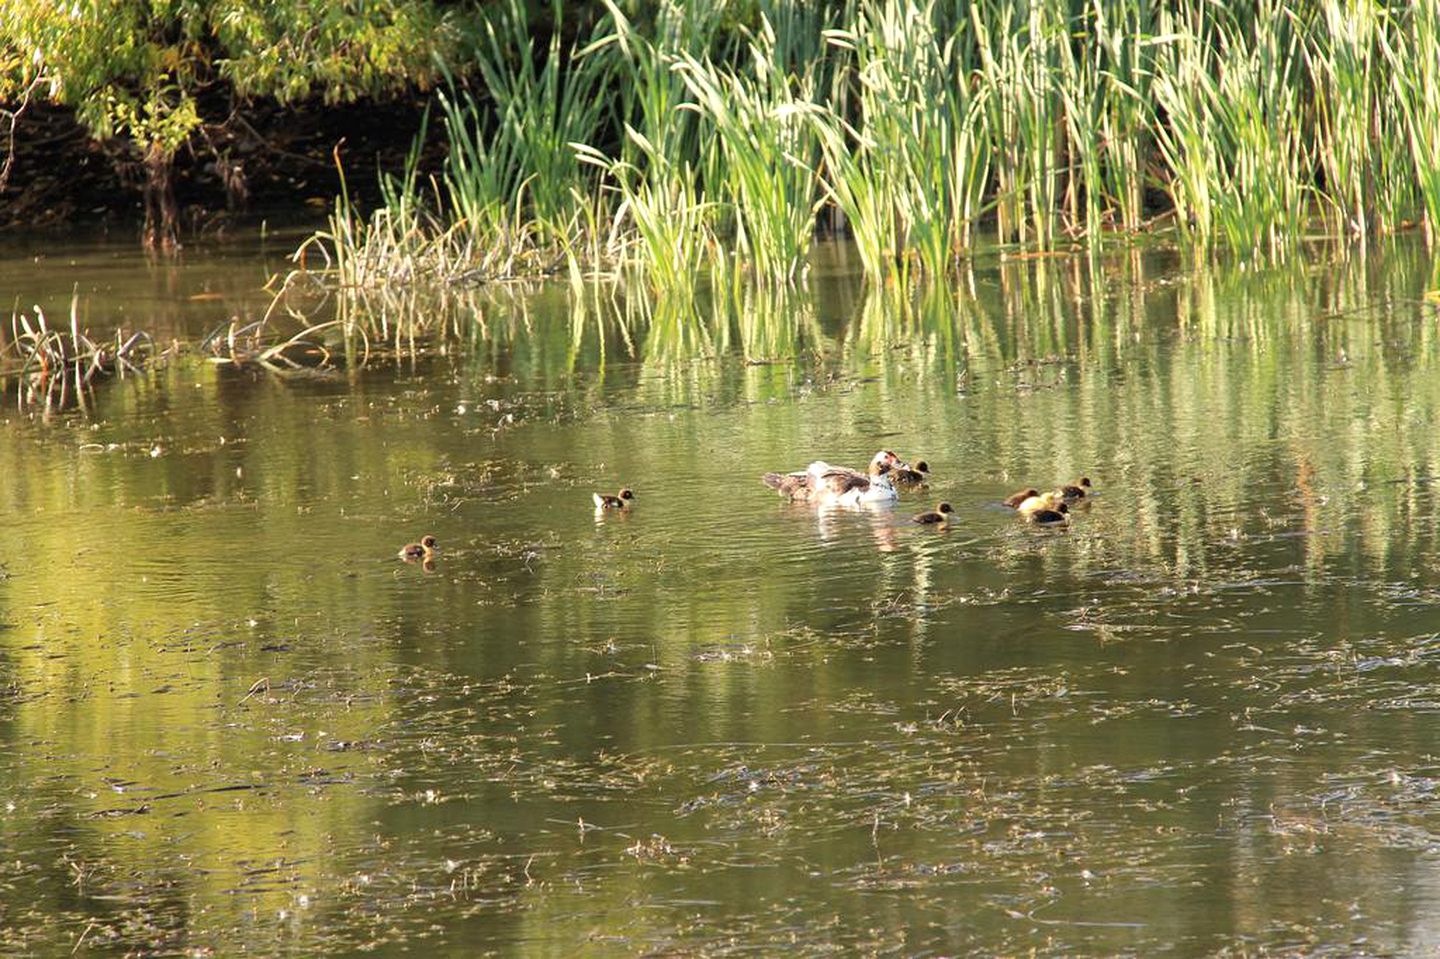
[0,0,469,243]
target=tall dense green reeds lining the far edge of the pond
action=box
[283,0,1440,303]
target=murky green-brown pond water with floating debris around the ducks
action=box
[0,237,1440,955]
